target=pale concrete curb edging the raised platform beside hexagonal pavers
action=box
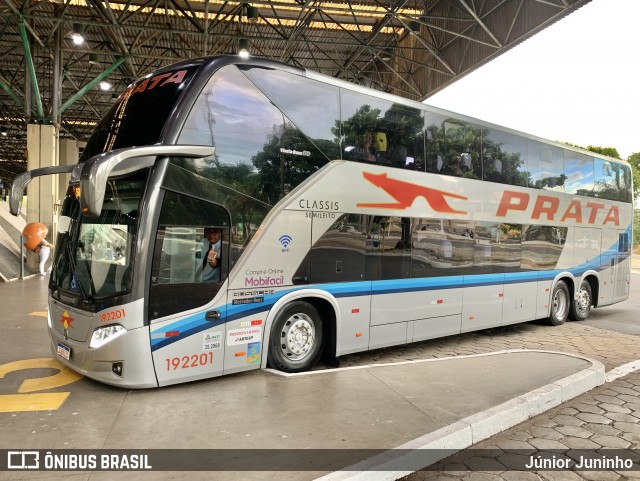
[315,349,604,481]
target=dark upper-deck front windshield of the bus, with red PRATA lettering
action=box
[80,66,198,161]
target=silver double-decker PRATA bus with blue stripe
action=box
[11,56,633,388]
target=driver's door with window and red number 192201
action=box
[147,192,230,386]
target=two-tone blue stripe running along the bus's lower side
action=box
[151,233,629,351]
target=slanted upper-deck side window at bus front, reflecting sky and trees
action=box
[179,66,328,204]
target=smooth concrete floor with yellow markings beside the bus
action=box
[0,277,604,481]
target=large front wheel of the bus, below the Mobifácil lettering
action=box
[268,301,322,372]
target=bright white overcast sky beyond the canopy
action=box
[425,0,640,159]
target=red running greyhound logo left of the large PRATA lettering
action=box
[356,172,468,214]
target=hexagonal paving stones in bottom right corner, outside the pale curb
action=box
[402,371,640,481]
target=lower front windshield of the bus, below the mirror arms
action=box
[51,171,147,299]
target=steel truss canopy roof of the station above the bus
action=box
[0,0,589,179]
